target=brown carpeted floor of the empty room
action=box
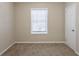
[3,43,77,56]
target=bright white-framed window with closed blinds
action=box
[31,8,48,34]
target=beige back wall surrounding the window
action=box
[16,2,65,42]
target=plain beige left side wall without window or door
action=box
[0,2,15,53]
